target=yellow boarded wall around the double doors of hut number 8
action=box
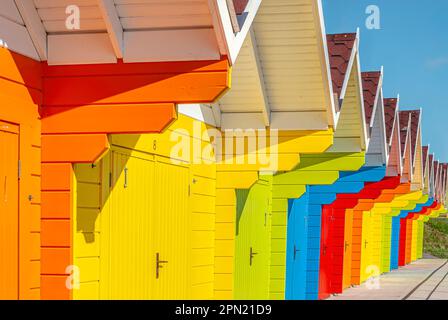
[73,116,217,299]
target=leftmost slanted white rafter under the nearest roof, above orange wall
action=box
[15,0,48,61]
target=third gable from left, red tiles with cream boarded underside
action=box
[327,30,369,152]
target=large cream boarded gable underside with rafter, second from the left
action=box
[213,0,336,130]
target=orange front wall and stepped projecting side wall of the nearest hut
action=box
[0,49,230,299]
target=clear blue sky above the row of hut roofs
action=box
[322,0,448,162]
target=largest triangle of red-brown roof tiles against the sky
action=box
[327,33,356,100]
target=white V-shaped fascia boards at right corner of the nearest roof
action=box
[208,0,262,65]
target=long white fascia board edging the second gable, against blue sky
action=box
[311,0,339,128]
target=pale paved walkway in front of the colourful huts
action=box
[329,259,448,300]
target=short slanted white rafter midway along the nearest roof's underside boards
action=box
[97,0,124,59]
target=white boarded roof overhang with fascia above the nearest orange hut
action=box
[0,0,261,65]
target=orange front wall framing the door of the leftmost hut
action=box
[0,48,42,299]
